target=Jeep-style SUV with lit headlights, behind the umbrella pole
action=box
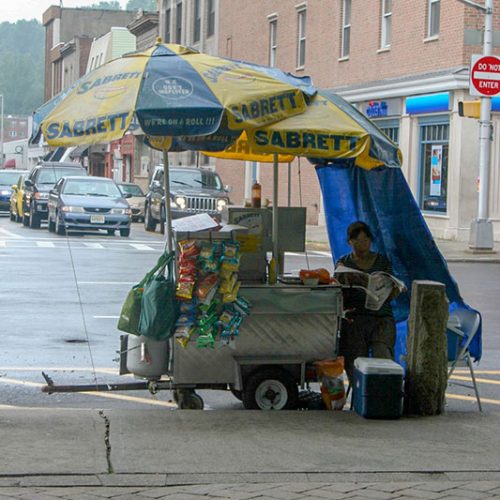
[144,166,230,231]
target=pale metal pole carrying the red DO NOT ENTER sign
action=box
[458,0,493,252]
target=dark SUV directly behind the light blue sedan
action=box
[23,162,87,229]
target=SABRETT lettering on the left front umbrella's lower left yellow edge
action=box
[46,113,129,140]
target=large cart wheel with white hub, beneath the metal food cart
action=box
[243,367,298,410]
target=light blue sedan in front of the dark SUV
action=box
[48,176,131,237]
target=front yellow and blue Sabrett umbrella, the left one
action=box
[33,43,316,150]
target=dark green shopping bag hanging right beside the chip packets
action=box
[139,253,177,340]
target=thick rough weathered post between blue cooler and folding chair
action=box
[405,280,448,415]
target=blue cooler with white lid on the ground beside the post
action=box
[352,358,404,419]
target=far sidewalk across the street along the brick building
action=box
[306,226,500,263]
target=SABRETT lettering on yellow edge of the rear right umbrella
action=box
[255,130,359,151]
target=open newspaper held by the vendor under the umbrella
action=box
[335,264,406,311]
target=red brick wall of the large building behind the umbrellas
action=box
[217,0,500,223]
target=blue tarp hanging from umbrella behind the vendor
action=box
[316,160,481,365]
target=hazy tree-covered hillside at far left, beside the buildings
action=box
[0,19,45,115]
